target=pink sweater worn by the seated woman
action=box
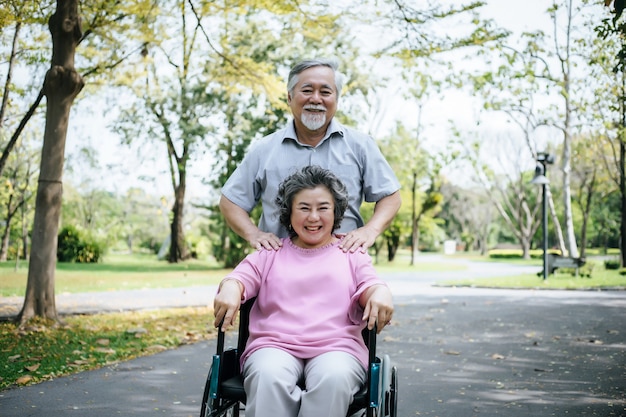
[222,238,385,367]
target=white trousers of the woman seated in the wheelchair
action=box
[243,348,367,417]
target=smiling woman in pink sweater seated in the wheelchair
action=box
[214,166,393,417]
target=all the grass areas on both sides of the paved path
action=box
[0,252,626,390]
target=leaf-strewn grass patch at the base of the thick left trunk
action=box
[0,307,215,390]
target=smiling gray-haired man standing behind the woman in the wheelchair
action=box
[220,59,401,252]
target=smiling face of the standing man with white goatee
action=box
[287,66,337,132]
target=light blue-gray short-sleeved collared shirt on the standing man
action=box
[222,119,400,237]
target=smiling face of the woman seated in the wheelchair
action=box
[291,186,335,249]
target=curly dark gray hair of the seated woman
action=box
[276,165,348,237]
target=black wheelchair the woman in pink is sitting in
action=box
[200,299,398,417]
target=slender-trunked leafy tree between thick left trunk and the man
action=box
[110,0,310,262]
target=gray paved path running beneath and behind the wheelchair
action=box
[0,255,626,417]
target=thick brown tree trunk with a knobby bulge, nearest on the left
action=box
[19,0,84,324]
